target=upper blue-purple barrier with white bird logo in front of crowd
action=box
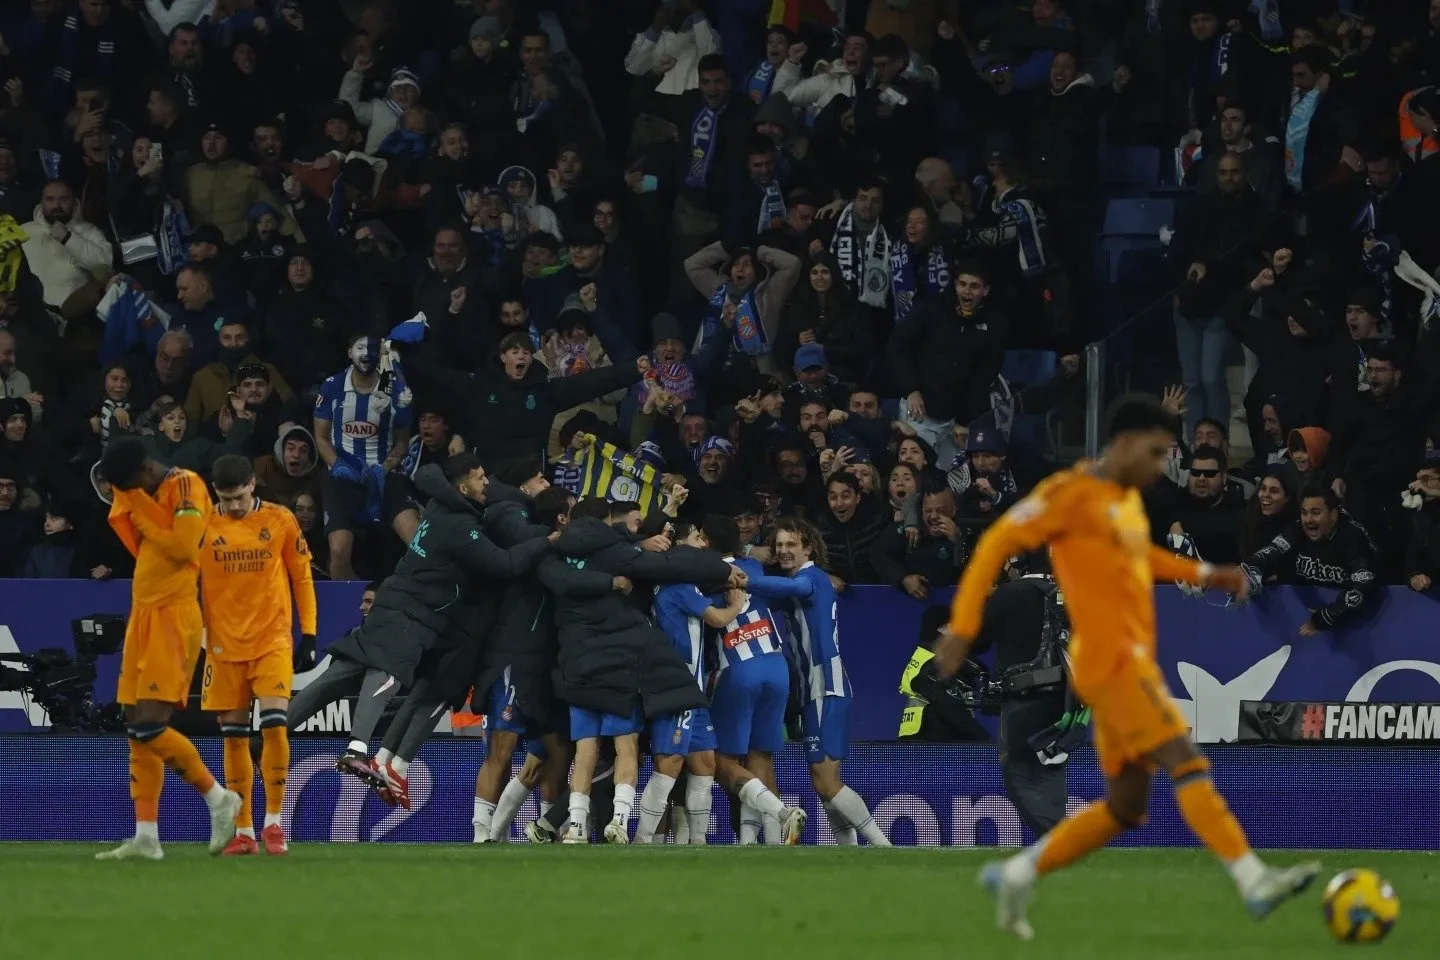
[0,580,1440,743]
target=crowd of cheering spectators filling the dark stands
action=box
[0,0,1440,624]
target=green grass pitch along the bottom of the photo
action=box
[0,843,1440,960]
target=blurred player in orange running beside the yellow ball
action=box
[936,396,1320,940]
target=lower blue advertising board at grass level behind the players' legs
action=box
[0,734,1440,849]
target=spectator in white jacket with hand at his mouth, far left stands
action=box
[22,180,114,315]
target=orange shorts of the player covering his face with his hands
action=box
[115,602,204,708]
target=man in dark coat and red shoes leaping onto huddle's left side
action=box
[291,455,550,779]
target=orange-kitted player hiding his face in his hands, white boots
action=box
[95,436,240,861]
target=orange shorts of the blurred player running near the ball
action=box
[1081,659,1189,777]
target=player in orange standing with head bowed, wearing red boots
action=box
[200,453,315,856]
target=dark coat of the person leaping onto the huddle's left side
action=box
[331,465,550,687]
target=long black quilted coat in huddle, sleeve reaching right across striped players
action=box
[541,517,730,717]
